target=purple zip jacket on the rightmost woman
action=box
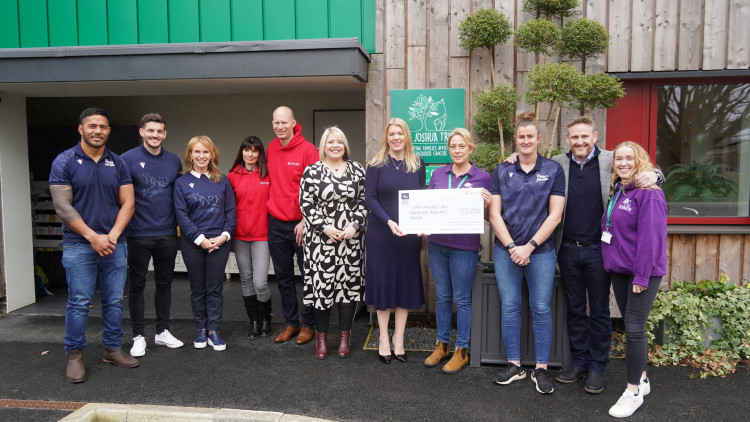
[602,184,667,287]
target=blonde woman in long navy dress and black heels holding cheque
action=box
[365,118,425,364]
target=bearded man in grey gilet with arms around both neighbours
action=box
[552,117,657,394]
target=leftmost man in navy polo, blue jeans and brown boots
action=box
[49,108,140,383]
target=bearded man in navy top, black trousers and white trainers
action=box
[122,113,183,357]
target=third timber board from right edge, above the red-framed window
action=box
[677,0,703,70]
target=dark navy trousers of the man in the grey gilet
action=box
[557,240,612,374]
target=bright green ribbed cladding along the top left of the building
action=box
[0,0,375,52]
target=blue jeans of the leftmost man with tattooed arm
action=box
[62,243,128,352]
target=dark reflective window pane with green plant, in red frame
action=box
[656,83,750,217]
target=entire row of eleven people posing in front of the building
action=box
[50,107,666,416]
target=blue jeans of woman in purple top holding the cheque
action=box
[427,242,479,349]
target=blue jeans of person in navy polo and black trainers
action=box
[494,245,555,364]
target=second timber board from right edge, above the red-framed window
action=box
[702,0,728,70]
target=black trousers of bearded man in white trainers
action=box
[128,234,177,337]
